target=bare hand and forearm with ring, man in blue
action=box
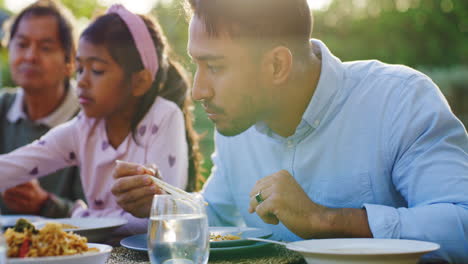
[249,170,372,239]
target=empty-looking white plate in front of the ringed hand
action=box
[287,238,440,264]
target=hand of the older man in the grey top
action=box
[3,180,49,215]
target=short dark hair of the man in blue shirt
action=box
[187,0,312,57]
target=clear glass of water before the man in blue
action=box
[148,194,210,264]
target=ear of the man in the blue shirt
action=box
[264,46,293,85]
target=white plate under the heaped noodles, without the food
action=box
[7,243,112,264]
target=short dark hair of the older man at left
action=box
[6,0,75,89]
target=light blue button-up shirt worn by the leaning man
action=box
[204,40,468,263]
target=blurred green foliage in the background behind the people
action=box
[0,0,468,179]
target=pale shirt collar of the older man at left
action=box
[7,88,79,128]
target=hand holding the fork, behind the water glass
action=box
[111,161,162,217]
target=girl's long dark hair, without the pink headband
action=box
[81,14,204,191]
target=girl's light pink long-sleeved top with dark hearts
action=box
[0,97,188,235]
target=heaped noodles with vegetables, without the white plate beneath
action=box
[4,218,99,258]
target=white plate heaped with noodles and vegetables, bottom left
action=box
[4,219,112,264]
